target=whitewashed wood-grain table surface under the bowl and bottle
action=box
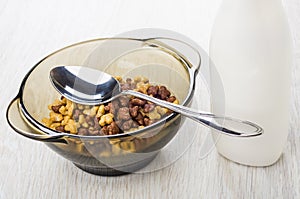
[0,0,300,199]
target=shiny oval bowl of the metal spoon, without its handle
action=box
[50,66,121,105]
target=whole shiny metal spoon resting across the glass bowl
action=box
[50,66,263,137]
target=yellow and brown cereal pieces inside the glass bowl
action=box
[42,76,179,136]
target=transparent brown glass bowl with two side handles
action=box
[7,38,200,175]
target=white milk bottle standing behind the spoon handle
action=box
[210,0,292,166]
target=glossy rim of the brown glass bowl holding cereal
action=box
[15,37,201,139]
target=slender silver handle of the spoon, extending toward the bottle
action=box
[122,90,263,137]
